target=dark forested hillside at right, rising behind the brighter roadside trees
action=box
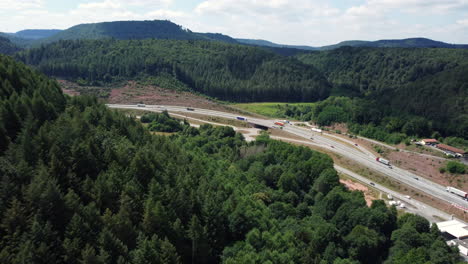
[298,47,468,139]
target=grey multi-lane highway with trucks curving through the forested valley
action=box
[107,104,468,208]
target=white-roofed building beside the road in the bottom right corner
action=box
[436,220,468,256]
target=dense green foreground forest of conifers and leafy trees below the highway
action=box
[0,55,459,264]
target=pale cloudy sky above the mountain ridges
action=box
[0,0,468,46]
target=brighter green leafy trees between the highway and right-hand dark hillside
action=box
[262,96,468,149]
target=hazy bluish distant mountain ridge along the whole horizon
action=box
[0,20,468,51]
